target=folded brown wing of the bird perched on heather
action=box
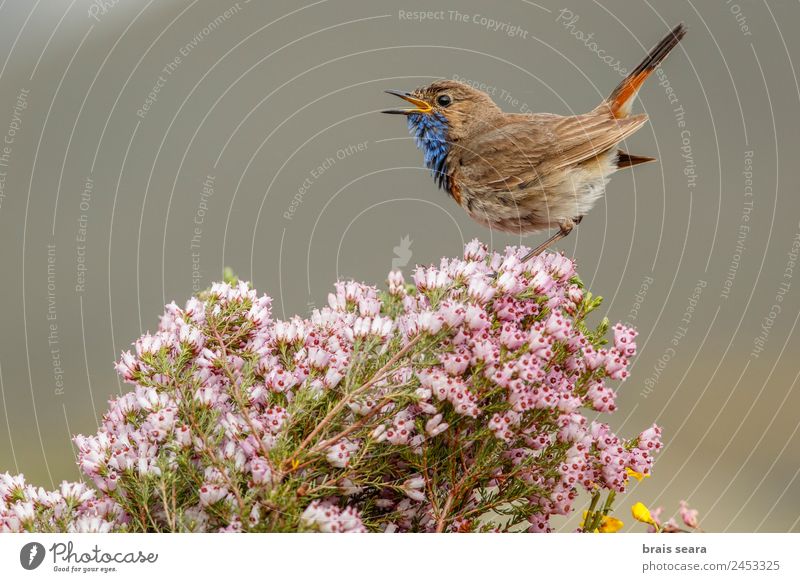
[459,113,647,190]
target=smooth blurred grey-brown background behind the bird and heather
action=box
[0,0,800,531]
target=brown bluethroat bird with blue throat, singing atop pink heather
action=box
[383,23,686,260]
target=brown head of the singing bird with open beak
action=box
[383,80,500,141]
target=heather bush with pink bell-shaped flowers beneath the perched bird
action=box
[0,241,696,532]
